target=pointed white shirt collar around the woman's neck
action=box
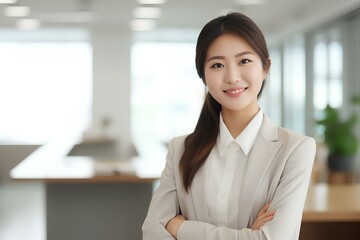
[217,109,263,157]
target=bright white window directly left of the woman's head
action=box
[131,43,204,146]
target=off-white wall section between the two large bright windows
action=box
[91,28,131,156]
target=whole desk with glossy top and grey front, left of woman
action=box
[10,139,165,240]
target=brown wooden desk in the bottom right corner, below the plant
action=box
[300,184,360,240]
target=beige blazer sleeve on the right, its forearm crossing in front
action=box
[177,138,316,240]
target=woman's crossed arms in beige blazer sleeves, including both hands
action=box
[143,136,315,240]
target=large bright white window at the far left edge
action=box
[0,42,92,144]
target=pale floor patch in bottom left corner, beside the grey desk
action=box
[0,182,46,240]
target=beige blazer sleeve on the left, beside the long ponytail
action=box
[142,140,180,240]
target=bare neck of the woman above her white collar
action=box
[222,107,259,138]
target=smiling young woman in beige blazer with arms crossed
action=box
[143,13,315,240]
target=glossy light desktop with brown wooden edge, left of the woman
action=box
[10,134,166,183]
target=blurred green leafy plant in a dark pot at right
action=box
[317,97,360,172]
